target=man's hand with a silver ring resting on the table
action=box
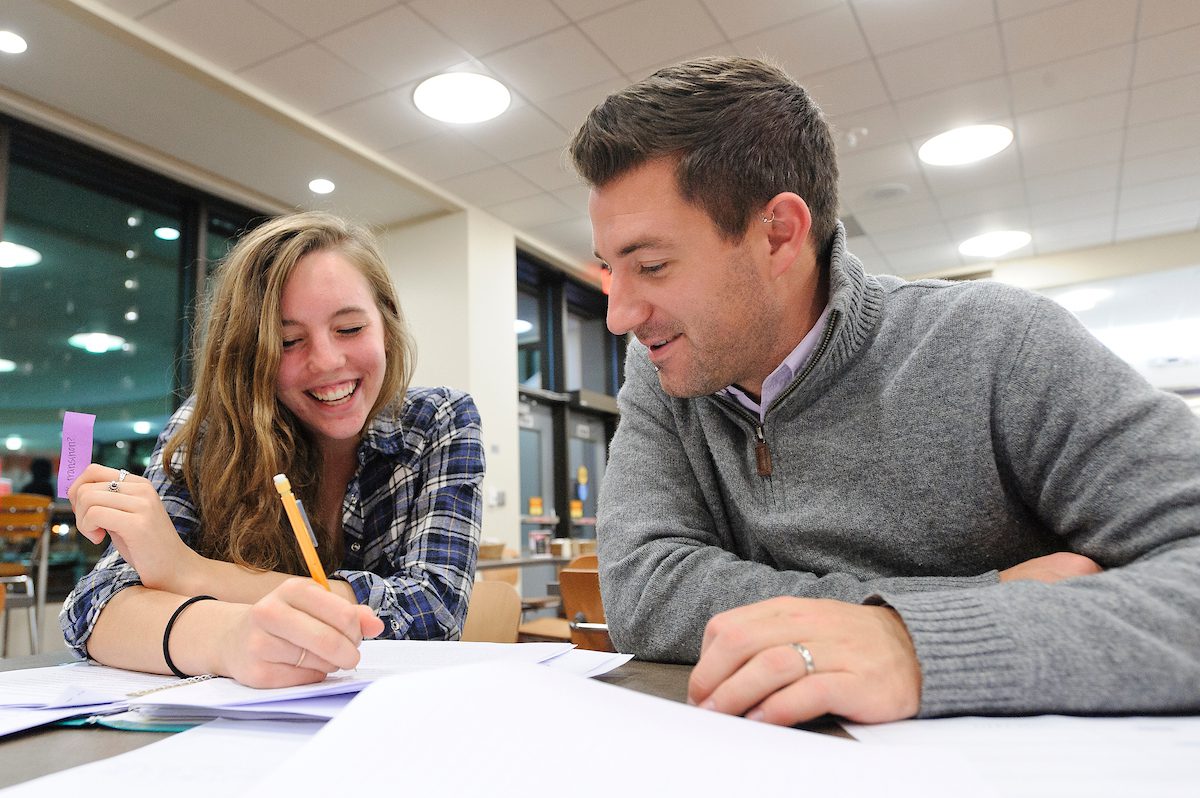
[688,598,920,726]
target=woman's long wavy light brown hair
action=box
[163,212,415,574]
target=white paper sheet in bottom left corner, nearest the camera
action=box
[0,720,319,798]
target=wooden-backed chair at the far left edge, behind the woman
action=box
[0,493,53,656]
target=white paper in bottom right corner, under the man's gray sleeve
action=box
[846,715,1200,798]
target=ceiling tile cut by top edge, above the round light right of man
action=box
[853,0,996,55]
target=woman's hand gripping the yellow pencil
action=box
[212,577,383,688]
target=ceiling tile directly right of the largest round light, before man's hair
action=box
[480,26,619,102]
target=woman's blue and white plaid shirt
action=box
[60,388,484,656]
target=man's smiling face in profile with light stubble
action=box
[588,160,779,397]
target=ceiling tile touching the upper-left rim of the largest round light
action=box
[318,6,470,86]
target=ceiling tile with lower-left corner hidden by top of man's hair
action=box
[733,6,870,76]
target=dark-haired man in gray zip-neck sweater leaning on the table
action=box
[571,59,1200,724]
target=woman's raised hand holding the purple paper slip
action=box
[67,463,205,595]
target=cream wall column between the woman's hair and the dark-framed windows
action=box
[379,211,521,548]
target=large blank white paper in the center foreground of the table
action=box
[241,662,994,798]
